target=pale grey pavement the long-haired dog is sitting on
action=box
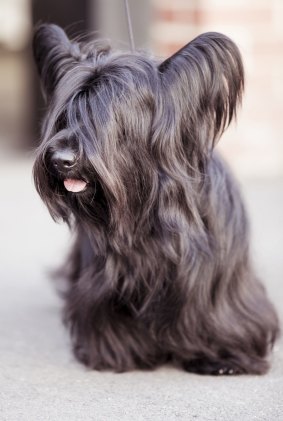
[0,159,283,421]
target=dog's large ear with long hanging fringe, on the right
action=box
[159,32,244,154]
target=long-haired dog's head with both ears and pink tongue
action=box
[33,24,243,231]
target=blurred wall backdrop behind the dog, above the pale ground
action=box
[0,0,283,178]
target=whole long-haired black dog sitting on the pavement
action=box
[34,25,278,374]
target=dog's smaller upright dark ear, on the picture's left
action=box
[33,24,80,98]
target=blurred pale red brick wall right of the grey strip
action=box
[152,0,283,177]
